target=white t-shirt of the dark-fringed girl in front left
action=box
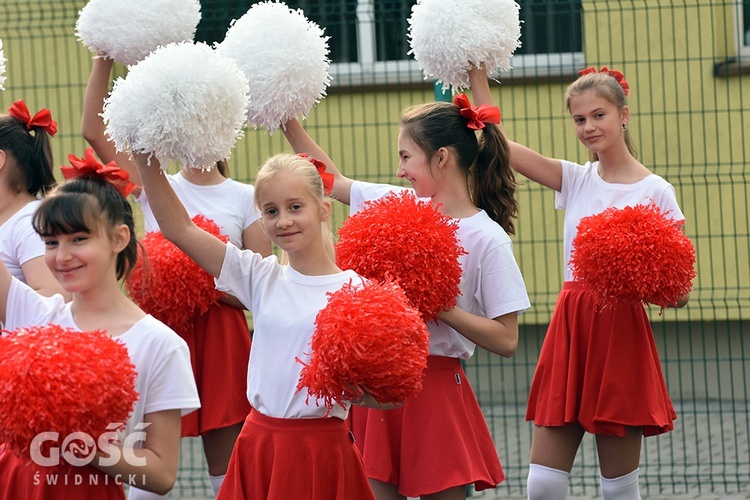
[5,279,200,442]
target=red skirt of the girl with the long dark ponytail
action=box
[350,356,505,497]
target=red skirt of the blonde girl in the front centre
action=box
[217,410,375,500]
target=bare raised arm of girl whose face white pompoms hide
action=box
[81,57,141,191]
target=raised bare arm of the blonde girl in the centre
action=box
[133,154,226,277]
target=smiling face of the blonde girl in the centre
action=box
[258,172,330,254]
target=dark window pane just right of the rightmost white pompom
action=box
[515,0,583,55]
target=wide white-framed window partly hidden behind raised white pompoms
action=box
[196,0,583,86]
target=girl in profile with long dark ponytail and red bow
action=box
[282,87,530,499]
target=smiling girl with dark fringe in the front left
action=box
[0,165,200,500]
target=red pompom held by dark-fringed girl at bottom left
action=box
[0,325,138,459]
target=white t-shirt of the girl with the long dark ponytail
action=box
[350,181,531,359]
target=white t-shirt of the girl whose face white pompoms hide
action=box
[136,172,260,248]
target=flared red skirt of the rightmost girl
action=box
[526,282,677,436]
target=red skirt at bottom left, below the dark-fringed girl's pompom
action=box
[0,445,126,500]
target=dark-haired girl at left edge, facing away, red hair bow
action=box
[0,100,67,297]
